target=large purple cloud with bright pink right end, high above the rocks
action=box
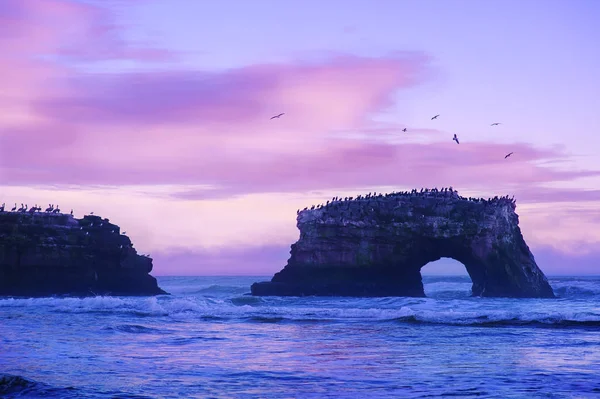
[36,54,425,126]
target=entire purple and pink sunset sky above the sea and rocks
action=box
[0,0,600,276]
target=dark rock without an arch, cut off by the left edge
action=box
[0,212,166,296]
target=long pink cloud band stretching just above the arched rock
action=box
[161,140,600,198]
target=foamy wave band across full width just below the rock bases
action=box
[0,296,600,328]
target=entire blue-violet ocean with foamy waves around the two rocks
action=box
[0,276,600,399]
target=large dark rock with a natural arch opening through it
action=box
[251,188,554,298]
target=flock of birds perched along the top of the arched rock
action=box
[296,187,516,215]
